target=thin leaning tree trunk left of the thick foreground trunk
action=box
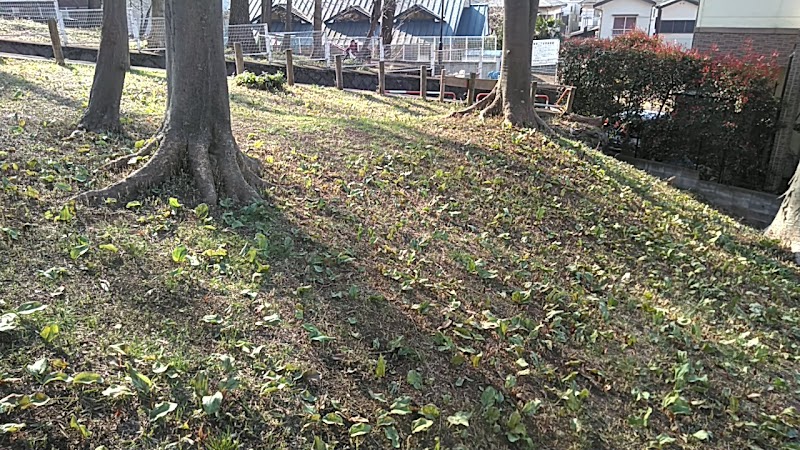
[78,0,130,132]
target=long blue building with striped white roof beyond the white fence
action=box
[250,0,489,44]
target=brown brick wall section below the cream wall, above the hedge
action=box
[692,28,800,66]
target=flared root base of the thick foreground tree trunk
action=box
[74,128,270,207]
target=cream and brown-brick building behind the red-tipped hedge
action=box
[692,0,800,191]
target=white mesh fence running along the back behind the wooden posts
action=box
[0,0,560,78]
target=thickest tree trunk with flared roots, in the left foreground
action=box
[78,0,266,207]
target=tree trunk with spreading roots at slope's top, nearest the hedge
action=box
[453,0,552,133]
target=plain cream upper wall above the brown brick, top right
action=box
[692,0,800,29]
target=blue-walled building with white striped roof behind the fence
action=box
[250,0,489,44]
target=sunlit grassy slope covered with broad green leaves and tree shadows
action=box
[0,61,800,449]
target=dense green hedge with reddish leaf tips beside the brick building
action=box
[560,33,779,189]
